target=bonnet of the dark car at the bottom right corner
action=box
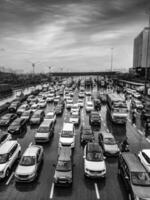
[132,185,150,200]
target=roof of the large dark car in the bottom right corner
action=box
[122,152,145,172]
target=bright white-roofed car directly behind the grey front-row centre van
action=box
[59,123,75,148]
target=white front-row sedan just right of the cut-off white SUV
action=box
[15,145,44,182]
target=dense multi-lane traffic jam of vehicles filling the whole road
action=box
[0,77,150,200]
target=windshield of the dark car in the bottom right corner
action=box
[131,172,150,186]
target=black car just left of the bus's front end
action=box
[89,111,101,127]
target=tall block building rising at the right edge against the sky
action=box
[133,27,150,69]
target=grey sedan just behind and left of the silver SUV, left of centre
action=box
[30,110,45,125]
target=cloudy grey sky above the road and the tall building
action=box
[0,0,150,72]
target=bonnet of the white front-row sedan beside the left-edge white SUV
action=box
[15,165,36,175]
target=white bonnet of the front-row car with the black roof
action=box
[85,160,106,171]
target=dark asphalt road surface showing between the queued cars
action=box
[0,88,150,200]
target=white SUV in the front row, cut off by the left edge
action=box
[0,140,21,180]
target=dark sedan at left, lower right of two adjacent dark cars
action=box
[8,118,26,134]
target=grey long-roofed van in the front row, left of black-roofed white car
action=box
[54,147,73,186]
